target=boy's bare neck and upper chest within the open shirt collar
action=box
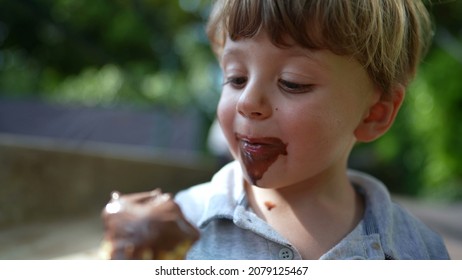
[246,168,363,259]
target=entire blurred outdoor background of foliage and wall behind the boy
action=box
[0,0,462,259]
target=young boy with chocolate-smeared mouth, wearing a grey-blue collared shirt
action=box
[176,0,448,259]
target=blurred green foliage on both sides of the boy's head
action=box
[0,0,462,199]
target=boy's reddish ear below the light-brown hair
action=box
[354,84,405,142]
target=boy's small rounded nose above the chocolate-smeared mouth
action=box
[236,84,272,120]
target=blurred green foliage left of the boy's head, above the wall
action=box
[0,0,220,116]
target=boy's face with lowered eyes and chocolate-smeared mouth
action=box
[218,32,378,188]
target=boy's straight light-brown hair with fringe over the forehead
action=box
[207,0,432,93]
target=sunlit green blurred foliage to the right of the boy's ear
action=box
[368,41,462,200]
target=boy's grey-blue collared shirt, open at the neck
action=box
[175,162,449,260]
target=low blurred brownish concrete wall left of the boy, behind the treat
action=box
[0,134,217,228]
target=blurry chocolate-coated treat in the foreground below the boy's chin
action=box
[101,189,199,260]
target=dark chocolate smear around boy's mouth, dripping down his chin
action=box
[239,137,287,185]
